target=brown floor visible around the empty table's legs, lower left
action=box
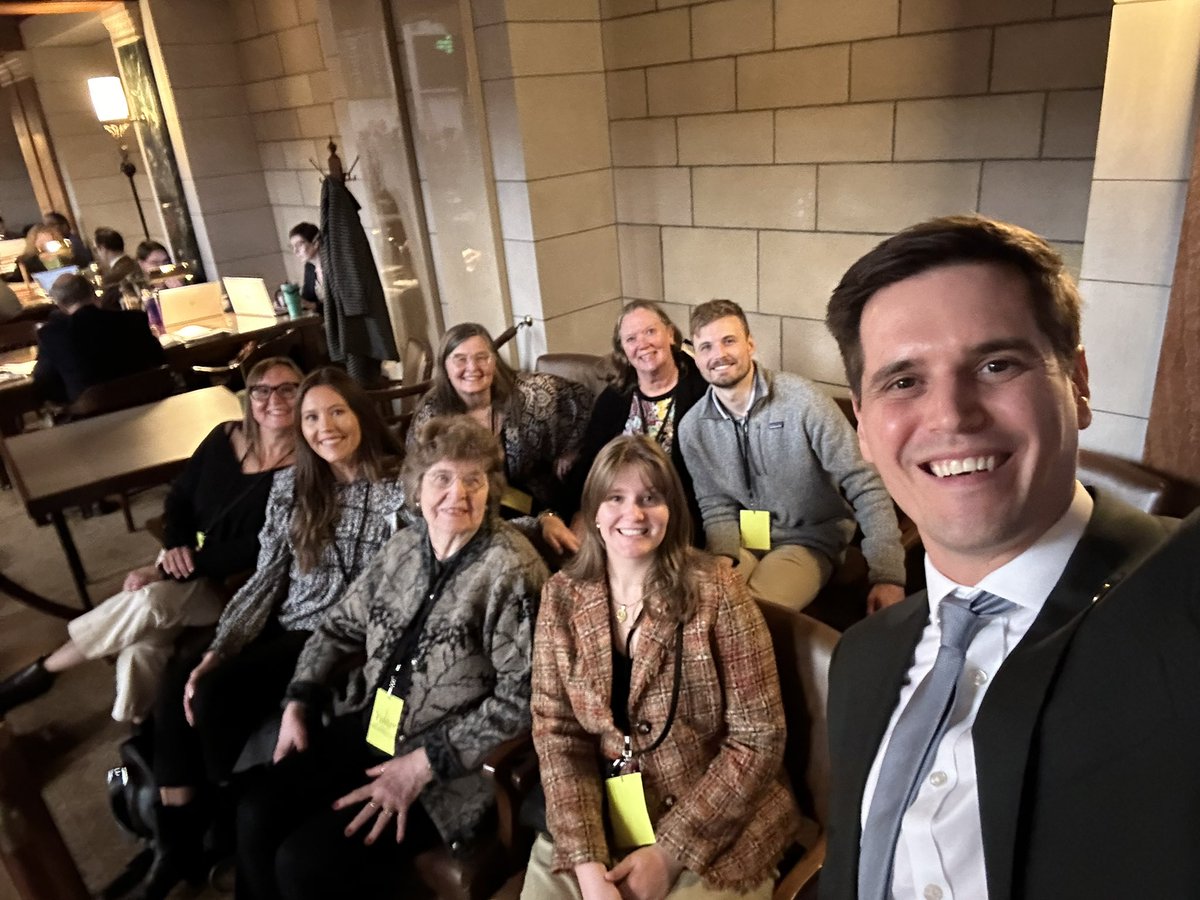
[0,491,520,900]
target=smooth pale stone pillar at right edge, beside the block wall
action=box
[1080,0,1200,460]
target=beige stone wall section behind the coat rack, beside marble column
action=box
[142,0,336,286]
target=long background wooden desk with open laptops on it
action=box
[0,314,329,436]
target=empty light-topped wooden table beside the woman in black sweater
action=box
[0,388,241,618]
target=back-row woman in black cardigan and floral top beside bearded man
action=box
[564,300,708,533]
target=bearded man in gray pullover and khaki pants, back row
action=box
[679,300,905,612]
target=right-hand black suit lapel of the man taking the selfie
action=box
[973,496,1163,898]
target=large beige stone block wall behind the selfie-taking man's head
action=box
[601,0,1109,385]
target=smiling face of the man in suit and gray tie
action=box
[856,263,1091,584]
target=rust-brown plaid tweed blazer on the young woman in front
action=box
[533,551,798,889]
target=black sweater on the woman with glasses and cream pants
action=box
[163,422,275,578]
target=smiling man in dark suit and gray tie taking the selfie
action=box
[821,217,1200,900]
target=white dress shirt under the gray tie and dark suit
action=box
[862,481,1093,900]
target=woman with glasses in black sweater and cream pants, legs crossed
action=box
[0,356,302,722]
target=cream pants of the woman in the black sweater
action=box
[67,578,226,722]
